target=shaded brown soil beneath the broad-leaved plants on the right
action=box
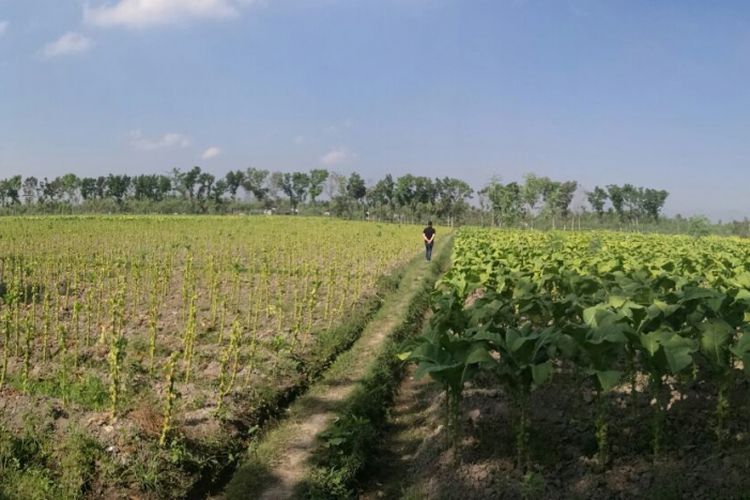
[360,366,750,500]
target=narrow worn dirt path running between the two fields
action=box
[226,240,450,500]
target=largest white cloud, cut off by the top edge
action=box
[83,0,257,28]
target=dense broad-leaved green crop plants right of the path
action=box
[408,229,750,467]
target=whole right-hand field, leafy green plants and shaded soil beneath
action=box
[396,228,750,498]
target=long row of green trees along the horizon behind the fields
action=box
[0,166,668,227]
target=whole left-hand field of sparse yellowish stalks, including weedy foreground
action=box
[0,217,420,498]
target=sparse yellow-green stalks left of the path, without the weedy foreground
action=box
[0,217,419,496]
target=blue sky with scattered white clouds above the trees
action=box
[0,0,750,220]
